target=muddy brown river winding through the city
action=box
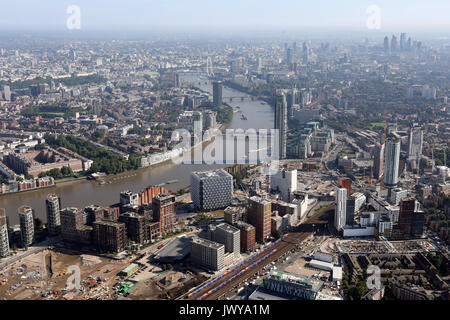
[0,74,274,224]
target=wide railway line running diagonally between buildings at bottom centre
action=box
[184,204,334,300]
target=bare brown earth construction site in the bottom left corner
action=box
[0,250,128,300]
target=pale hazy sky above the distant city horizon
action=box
[0,0,450,32]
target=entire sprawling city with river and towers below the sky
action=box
[0,0,450,306]
